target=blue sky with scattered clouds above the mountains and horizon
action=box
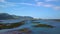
[0,0,60,19]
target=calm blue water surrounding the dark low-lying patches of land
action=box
[0,20,60,34]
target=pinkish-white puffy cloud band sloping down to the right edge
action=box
[35,0,60,10]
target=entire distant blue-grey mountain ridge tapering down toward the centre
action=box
[0,13,33,20]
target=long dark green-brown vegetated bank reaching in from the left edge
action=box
[0,21,25,29]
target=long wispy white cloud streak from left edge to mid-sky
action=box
[0,2,35,8]
